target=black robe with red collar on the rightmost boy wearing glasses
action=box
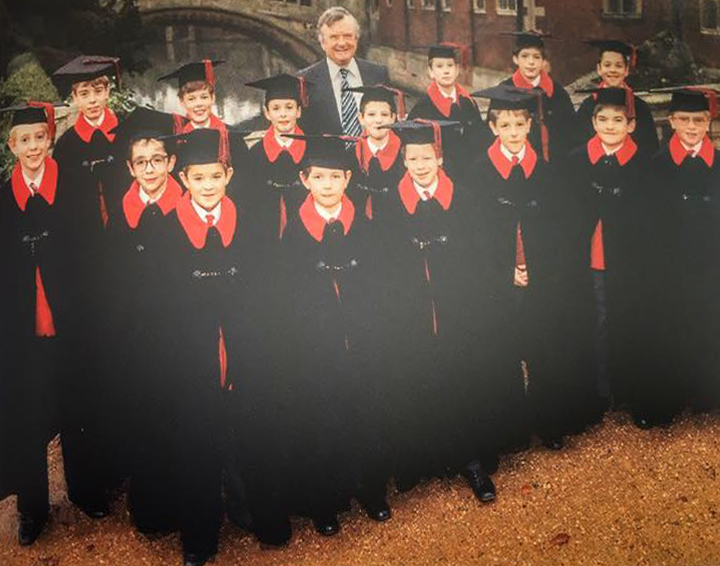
[650,135,720,416]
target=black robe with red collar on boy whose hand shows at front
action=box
[475,142,594,449]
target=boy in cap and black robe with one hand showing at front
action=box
[474,85,591,450]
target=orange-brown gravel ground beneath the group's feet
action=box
[0,414,720,566]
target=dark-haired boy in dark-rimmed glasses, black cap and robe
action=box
[106,107,183,535]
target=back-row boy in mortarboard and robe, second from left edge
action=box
[53,55,120,518]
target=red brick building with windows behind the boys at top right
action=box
[371,0,720,83]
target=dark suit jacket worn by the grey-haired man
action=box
[299,57,390,134]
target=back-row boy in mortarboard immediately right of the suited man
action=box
[408,44,490,180]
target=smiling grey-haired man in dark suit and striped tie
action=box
[300,6,390,136]
